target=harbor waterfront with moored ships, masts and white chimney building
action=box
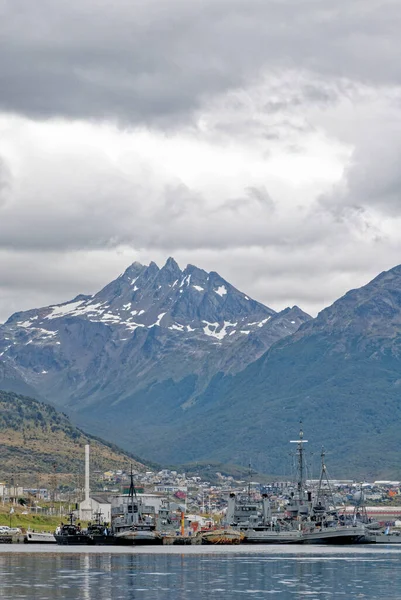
[0,424,401,547]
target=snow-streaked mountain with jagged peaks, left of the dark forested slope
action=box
[0,258,310,436]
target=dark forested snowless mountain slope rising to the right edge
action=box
[154,266,401,478]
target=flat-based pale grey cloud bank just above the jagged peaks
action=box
[0,164,338,252]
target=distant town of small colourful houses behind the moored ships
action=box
[0,469,401,524]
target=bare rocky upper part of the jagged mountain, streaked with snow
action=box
[0,257,305,360]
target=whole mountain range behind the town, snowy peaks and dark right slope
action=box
[0,260,401,478]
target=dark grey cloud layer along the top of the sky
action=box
[0,0,401,126]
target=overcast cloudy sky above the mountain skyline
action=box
[0,0,401,322]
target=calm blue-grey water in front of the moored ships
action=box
[0,546,401,600]
